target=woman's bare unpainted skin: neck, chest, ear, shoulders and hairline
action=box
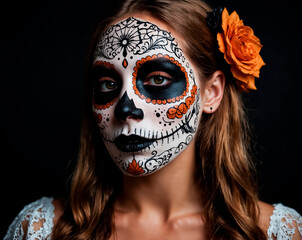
[53,15,274,240]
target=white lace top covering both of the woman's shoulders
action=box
[4,197,302,240]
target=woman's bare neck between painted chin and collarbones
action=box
[114,141,201,220]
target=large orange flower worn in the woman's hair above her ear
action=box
[217,9,265,91]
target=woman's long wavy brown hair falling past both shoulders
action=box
[53,0,265,240]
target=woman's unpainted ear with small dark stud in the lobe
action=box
[203,70,225,113]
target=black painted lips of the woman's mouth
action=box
[114,134,155,152]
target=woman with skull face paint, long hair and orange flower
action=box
[5,0,302,239]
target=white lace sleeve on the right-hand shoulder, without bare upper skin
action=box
[267,203,302,240]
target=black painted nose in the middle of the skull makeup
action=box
[114,91,144,121]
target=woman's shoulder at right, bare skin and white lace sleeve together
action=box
[259,202,302,240]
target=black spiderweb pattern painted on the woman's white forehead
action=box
[94,17,185,68]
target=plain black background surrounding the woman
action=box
[0,0,302,237]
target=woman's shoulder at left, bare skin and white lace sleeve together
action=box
[4,197,62,240]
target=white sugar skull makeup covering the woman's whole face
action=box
[93,17,201,176]
